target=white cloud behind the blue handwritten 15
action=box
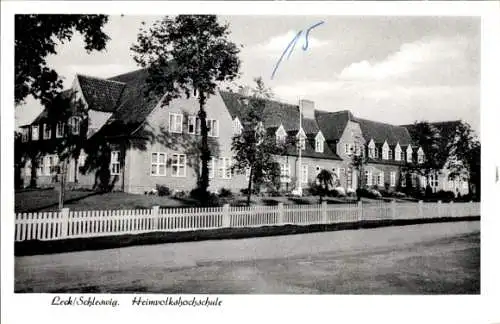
[248,30,329,56]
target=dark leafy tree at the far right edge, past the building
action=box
[448,121,481,198]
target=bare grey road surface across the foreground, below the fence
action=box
[15,221,480,294]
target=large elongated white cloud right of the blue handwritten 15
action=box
[338,36,471,81]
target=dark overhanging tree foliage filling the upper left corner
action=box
[14,14,110,105]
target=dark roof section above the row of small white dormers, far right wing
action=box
[354,118,411,146]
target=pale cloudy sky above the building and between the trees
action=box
[16,16,481,135]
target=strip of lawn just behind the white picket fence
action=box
[14,189,414,213]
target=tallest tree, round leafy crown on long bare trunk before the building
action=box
[131,15,240,200]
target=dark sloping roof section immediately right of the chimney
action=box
[314,110,354,141]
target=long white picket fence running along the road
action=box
[15,202,480,242]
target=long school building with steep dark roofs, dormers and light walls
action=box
[16,70,466,194]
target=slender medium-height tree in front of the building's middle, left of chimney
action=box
[231,78,283,205]
